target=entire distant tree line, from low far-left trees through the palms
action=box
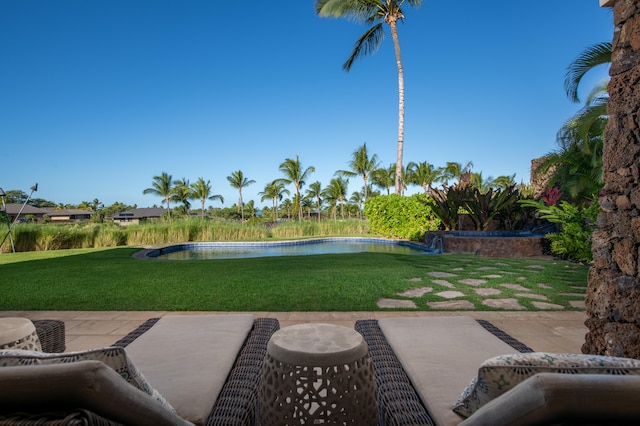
[0,143,515,221]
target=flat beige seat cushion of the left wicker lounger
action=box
[126,314,257,425]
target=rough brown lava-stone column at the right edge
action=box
[582,0,640,359]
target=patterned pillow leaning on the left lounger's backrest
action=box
[0,347,175,412]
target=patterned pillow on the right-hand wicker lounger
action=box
[453,352,640,417]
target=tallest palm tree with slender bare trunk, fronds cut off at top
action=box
[315,0,422,194]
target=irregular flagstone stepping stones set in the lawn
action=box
[378,263,586,311]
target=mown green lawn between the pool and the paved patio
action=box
[0,247,588,311]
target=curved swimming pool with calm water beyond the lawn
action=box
[143,238,430,260]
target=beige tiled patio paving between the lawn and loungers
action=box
[0,311,588,353]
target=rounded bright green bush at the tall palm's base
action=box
[364,194,440,241]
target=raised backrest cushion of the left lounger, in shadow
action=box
[0,361,193,426]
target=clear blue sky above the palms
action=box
[0,0,613,211]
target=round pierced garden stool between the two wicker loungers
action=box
[260,324,378,426]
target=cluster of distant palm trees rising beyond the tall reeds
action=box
[143,143,515,221]
